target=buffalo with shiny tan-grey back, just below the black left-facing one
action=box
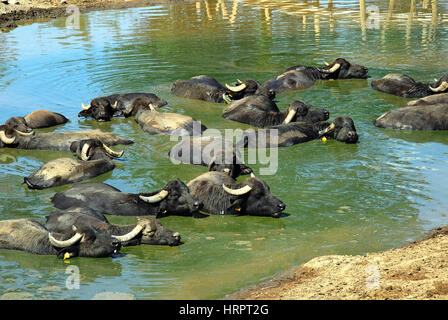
[129,100,207,136]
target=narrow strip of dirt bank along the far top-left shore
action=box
[0,0,178,32]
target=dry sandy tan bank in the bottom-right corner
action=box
[226,226,448,300]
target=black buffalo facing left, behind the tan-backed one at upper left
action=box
[78,93,167,121]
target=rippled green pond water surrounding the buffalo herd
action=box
[0,0,448,299]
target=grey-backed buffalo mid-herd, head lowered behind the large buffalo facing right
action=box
[169,136,252,179]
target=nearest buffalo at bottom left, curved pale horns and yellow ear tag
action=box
[0,219,121,258]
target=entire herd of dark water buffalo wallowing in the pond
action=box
[0,58,448,258]
